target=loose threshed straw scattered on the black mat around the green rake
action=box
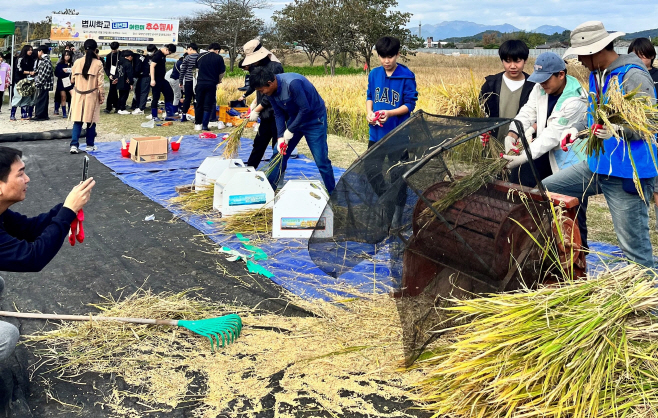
[27,290,422,417]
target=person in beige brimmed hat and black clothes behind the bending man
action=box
[241,39,283,168]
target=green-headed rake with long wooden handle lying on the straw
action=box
[0,311,242,352]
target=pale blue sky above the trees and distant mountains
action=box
[0,0,658,32]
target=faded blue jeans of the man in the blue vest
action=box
[542,161,654,268]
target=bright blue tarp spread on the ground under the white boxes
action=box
[92,135,644,300]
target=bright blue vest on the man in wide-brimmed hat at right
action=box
[587,64,658,179]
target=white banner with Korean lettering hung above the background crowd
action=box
[50,14,178,45]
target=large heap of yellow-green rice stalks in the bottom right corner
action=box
[414,266,658,418]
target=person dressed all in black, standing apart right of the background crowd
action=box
[194,42,226,131]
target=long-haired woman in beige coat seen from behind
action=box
[70,39,105,154]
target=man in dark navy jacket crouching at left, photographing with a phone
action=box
[0,147,96,361]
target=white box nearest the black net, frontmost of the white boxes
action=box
[272,180,334,239]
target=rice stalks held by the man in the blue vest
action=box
[587,77,658,155]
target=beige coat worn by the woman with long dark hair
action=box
[71,57,105,123]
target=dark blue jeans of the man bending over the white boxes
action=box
[267,116,336,194]
